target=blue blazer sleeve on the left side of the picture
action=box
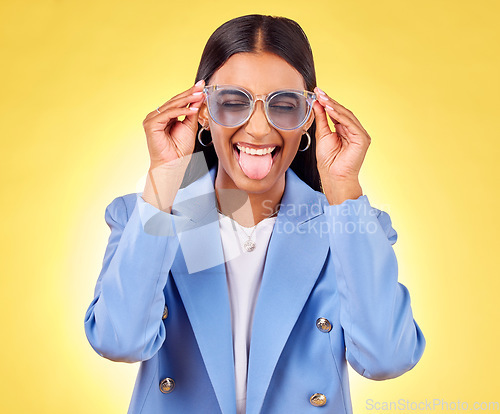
[84,193,188,362]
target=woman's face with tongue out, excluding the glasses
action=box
[199,52,314,193]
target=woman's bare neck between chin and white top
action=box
[215,169,285,227]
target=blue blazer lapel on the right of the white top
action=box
[247,169,329,414]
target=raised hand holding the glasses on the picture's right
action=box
[313,88,371,204]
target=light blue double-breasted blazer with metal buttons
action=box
[85,163,425,414]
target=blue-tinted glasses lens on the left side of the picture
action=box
[208,89,251,126]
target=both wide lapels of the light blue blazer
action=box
[171,162,329,414]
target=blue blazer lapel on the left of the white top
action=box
[171,162,236,414]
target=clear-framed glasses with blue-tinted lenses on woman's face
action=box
[203,84,316,130]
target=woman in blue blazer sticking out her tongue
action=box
[85,15,425,414]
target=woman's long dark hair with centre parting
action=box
[184,14,321,191]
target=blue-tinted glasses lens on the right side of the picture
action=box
[268,91,309,129]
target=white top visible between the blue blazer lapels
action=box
[219,213,276,414]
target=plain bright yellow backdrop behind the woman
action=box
[0,0,500,414]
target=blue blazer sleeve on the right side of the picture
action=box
[325,195,425,380]
